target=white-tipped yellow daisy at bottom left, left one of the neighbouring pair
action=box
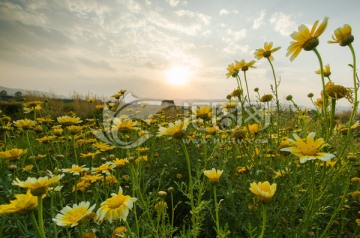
[52,201,96,227]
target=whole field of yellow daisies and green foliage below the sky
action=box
[0,18,360,238]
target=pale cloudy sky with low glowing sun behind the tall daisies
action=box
[0,0,360,106]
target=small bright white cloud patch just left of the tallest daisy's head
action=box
[270,12,296,36]
